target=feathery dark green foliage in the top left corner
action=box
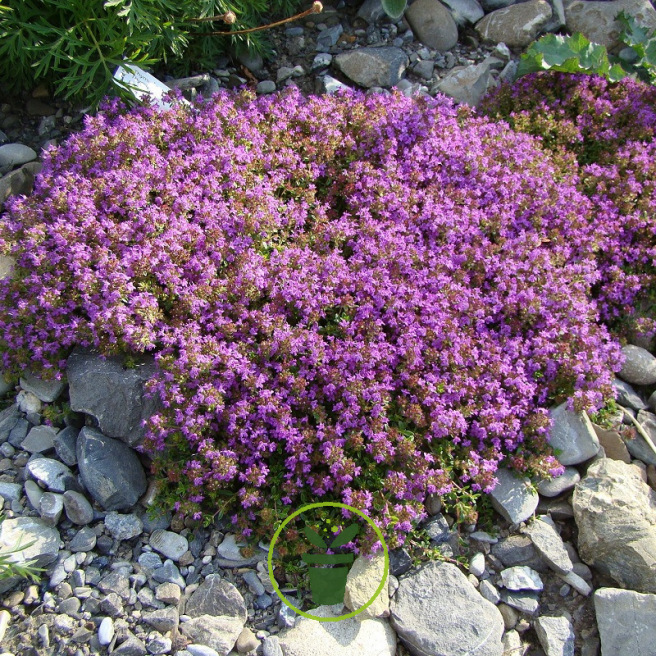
[0,0,300,105]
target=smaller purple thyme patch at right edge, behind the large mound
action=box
[482,73,656,338]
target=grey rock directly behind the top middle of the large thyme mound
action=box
[333,47,408,87]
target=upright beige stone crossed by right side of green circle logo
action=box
[344,553,389,621]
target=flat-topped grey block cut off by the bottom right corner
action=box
[594,588,656,656]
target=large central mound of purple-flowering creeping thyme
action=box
[0,87,619,547]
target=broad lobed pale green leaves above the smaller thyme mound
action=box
[517,12,656,84]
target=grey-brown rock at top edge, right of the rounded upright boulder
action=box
[476,0,552,48]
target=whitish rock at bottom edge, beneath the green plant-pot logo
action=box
[276,604,396,656]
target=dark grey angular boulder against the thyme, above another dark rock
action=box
[67,349,157,446]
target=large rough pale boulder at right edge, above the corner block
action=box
[572,458,656,593]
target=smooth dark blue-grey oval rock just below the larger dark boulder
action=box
[77,427,146,510]
